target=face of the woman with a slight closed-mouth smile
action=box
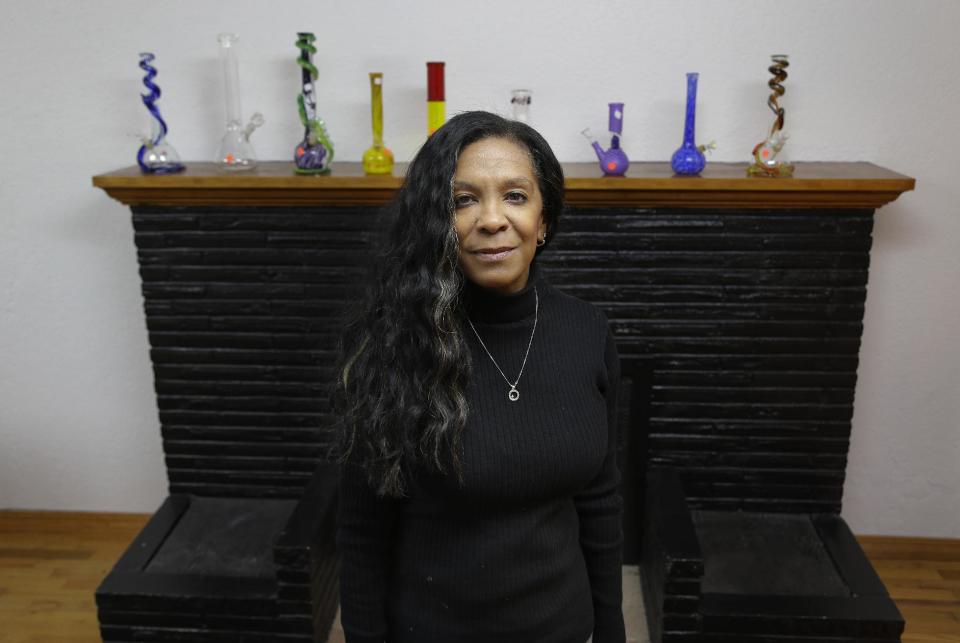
[453,138,547,294]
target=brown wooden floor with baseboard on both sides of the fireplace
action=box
[0,511,960,643]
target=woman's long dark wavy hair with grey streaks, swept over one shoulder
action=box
[328,111,564,497]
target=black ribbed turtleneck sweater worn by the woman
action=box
[337,261,625,643]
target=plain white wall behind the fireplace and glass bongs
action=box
[0,0,960,537]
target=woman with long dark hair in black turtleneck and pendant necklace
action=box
[333,112,625,643]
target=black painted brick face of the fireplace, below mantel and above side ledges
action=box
[133,206,873,511]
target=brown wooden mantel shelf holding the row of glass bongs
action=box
[93,161,915,208]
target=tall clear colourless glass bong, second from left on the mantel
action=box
[216,33,264,171]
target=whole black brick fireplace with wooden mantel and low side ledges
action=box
[94,163,913,643]
